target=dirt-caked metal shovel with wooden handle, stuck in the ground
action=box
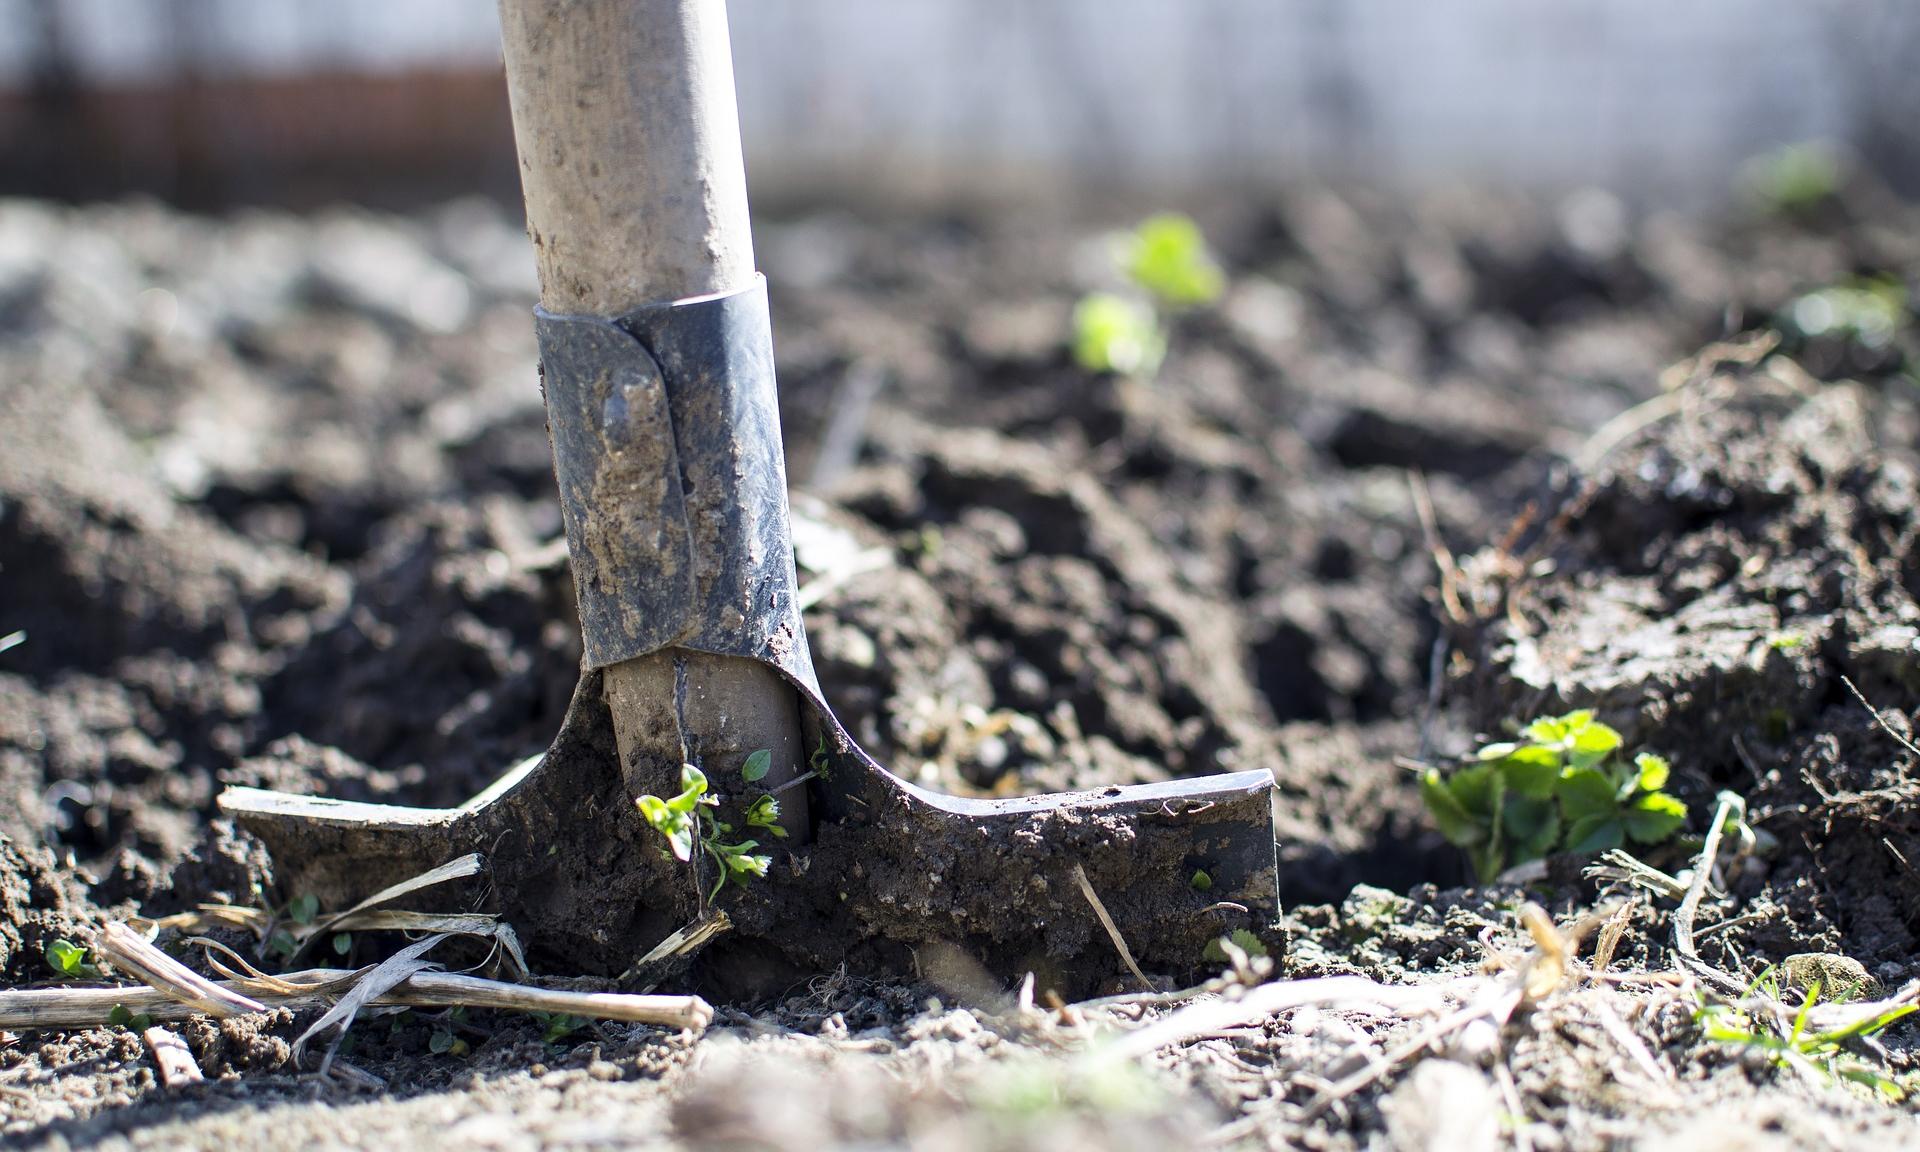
[219,0,1277,993]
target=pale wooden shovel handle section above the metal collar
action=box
[499,0,755,317]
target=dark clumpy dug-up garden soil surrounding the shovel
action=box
[0,175,1920,1152]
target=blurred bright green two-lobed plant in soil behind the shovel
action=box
[1073,213,1225,376]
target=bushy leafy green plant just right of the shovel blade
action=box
[1421,710,1686,883]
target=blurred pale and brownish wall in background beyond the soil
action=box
[0,0,1920,204]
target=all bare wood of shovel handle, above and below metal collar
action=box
[499,0,808,843]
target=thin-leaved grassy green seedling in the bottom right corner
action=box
[1693,968,1920,1102]
